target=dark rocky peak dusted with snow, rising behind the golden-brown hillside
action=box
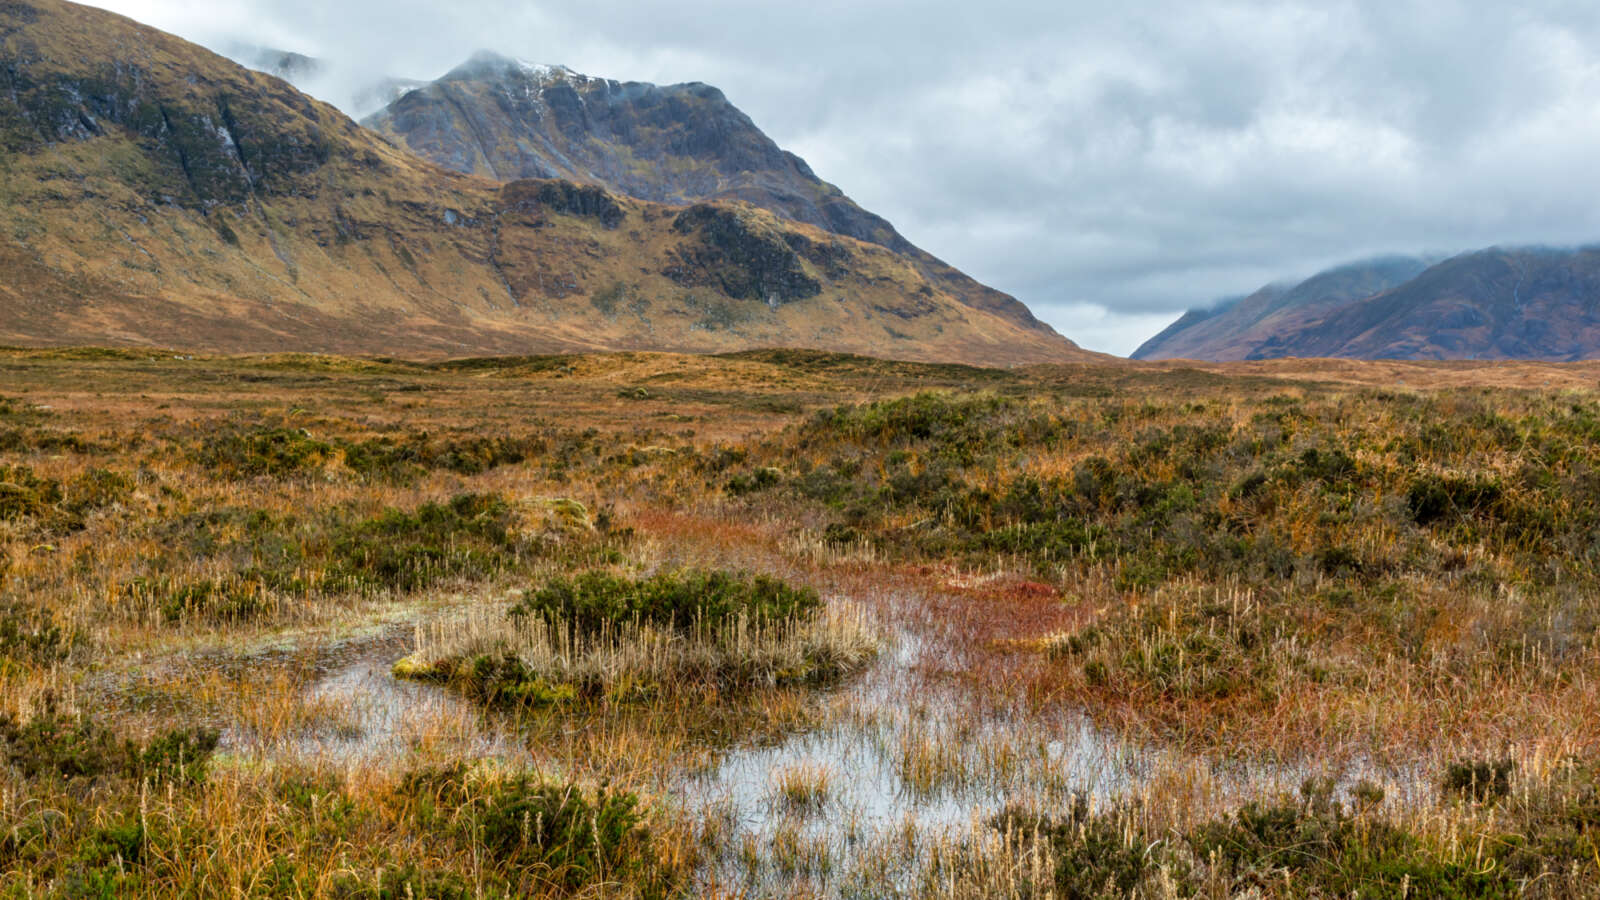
[365,51,1045,330]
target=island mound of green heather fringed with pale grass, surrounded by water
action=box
[395,570,874,705]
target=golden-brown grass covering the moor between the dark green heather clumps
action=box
[0,352,1600,897]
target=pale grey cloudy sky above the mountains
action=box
[84,0,1600,354]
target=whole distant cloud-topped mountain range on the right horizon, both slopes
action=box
[1134,248,1600,362]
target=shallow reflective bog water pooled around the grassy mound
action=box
[209,592,1426,897]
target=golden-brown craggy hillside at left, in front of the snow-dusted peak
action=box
[0,0,1088,364]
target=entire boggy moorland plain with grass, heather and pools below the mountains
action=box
[0,341,1600,898]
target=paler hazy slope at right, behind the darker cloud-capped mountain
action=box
[1133,256,1427,360]
